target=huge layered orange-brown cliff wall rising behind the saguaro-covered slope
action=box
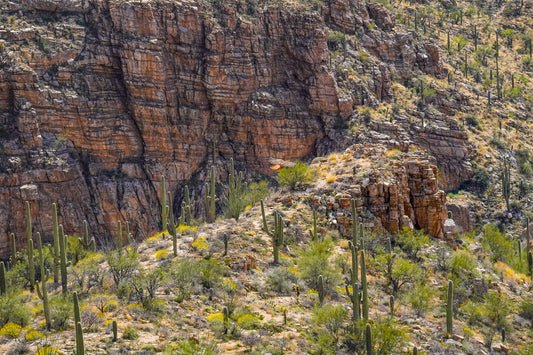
[0,0,466,254]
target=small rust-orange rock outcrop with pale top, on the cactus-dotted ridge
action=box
[308,144,447,238]
